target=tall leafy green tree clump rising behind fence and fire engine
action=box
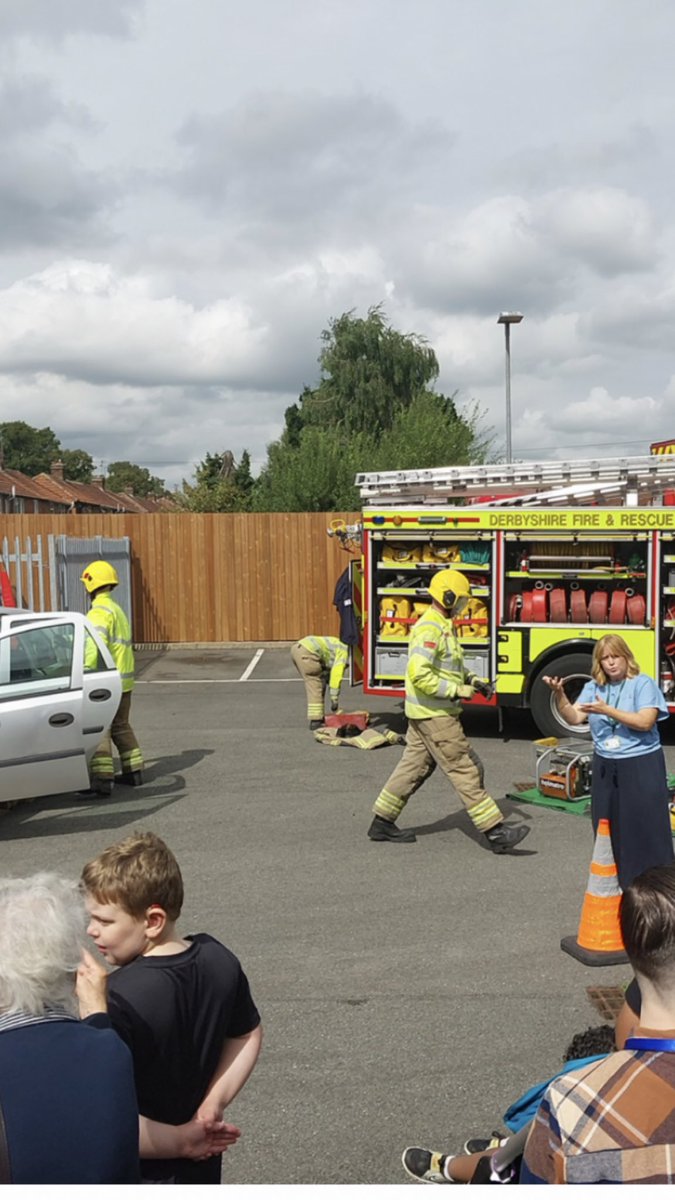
[251,306,491,511]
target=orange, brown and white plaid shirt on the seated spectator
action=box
[519,1030,675,1183]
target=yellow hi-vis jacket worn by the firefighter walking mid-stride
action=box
[406,607,466,721]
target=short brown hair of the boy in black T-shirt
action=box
[82,833,184,920]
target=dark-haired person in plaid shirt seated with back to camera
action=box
[520,865,675,1184]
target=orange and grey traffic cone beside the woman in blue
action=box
[560,818,628,967]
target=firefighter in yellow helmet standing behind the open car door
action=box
[80,560,143,796]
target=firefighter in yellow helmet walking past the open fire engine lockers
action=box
[368,569,530,854]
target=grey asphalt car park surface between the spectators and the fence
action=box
[0,644,675,1184]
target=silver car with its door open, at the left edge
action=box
[0,608,121,802]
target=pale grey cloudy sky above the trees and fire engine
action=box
[0,0,675,487]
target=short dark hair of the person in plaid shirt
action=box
[620,866,675,982]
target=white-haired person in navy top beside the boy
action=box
[0,874,239,1183]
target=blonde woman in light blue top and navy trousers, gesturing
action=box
[544,634,673,889]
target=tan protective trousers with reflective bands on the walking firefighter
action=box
[374,714,502,833]
